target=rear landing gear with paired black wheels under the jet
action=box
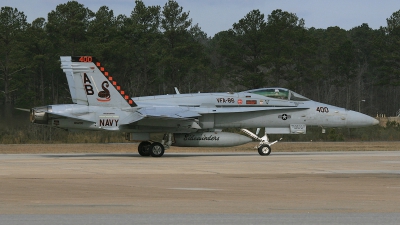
[138,134,172,157]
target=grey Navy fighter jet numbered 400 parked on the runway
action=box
[30,56,378,157]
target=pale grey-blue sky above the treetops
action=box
[0,0,400,36]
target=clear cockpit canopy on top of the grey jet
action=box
[245,88,310,101]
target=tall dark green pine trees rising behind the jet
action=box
[0,0,400,116]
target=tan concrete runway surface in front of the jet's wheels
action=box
[0,151,400,224]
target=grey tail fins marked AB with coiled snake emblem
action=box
[61,56,136,108]
